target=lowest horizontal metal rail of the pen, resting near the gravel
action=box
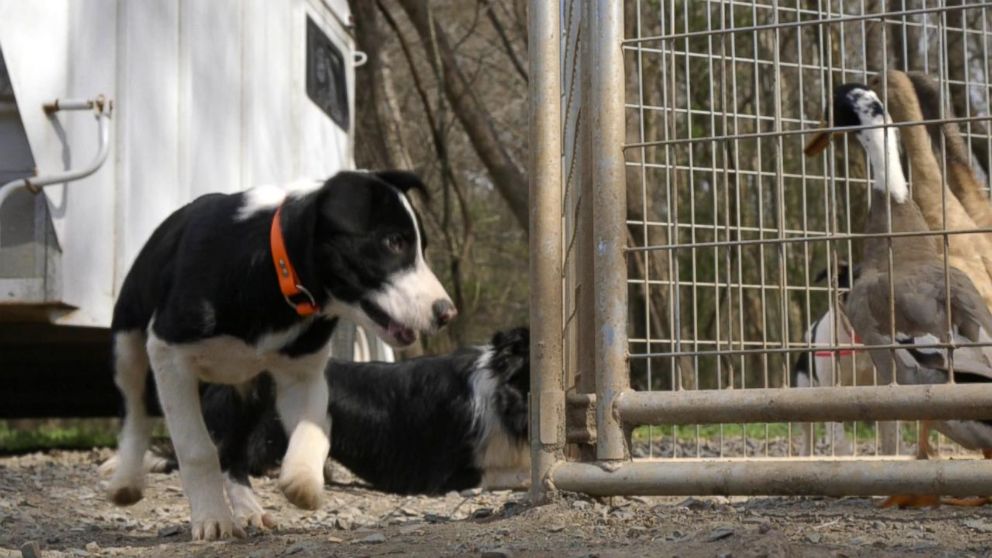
[551,459,992,496]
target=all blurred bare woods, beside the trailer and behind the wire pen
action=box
[351,0,992,398]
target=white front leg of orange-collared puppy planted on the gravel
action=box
[148,334,245,540]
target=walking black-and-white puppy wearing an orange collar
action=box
[109,171,455,539]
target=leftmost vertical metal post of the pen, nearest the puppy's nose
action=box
[528,0,565,503]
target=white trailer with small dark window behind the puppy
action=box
[0,0,392,416]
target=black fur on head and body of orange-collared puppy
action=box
[111,171,423,350]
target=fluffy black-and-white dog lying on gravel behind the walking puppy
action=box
[149,328,530,527]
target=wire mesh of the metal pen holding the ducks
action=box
[561,0,992,476]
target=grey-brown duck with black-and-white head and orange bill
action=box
[805,84,992,507]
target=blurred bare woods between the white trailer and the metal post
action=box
[350,0,528,354]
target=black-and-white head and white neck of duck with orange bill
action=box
[803,83,909,203]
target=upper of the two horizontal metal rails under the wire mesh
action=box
[604,384,992,425]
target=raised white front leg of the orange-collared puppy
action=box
[272,368,331,510]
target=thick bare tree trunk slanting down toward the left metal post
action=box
[397,0,529,231]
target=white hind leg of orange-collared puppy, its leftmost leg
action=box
[107,330,151,506]
